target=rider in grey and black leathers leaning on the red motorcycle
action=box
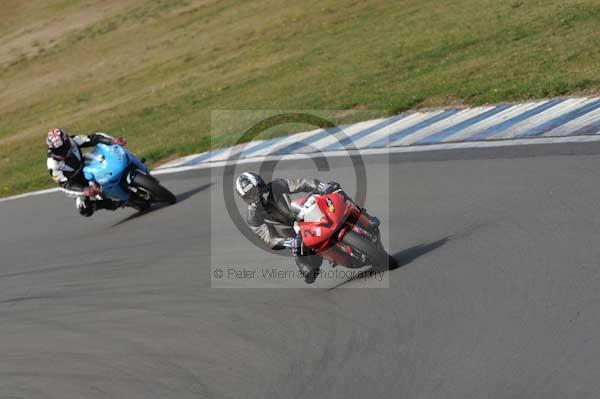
[236,172,379,284]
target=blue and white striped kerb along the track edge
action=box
[159,97,600,169]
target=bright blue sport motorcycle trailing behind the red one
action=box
[83,144,177,210]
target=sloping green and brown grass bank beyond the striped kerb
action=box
[0,0,600,196]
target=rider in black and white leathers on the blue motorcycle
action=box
[46,129,125,216]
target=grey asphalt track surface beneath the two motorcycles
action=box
[0,144,600,399]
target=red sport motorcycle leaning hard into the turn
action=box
[292,190,396,268]
